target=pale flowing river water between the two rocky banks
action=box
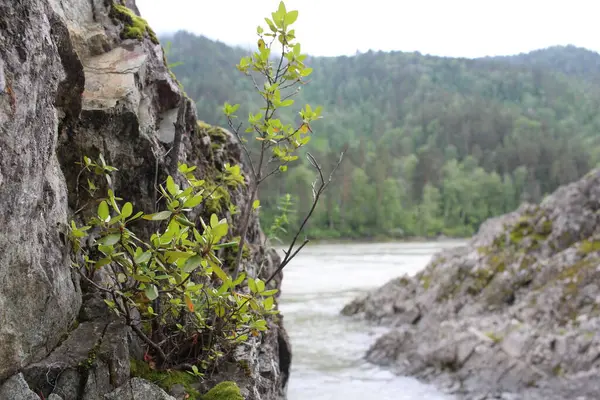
[280,242,459,400]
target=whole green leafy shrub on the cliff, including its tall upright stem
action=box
[69,3,341,392]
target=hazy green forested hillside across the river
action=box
[161,32,600,239]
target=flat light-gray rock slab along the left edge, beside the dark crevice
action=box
[0,0,81,381]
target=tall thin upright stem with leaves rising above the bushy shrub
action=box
[223,1,343,283]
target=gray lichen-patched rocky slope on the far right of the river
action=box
[342,170,600,400]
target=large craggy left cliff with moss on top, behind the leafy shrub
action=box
[0,0,291,400]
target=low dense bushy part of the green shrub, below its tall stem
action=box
[70,157,277,375]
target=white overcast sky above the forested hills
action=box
[136,0,600,57]
